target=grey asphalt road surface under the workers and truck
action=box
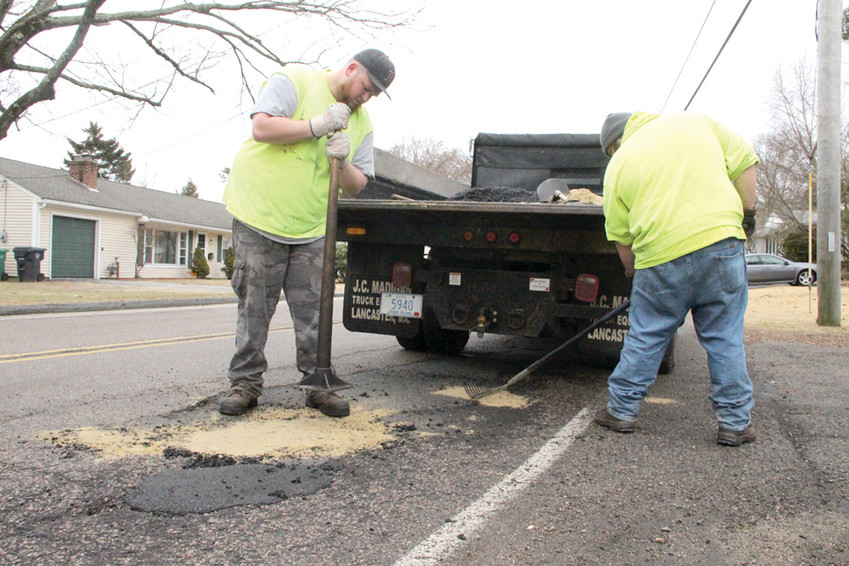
[0,305,849,565]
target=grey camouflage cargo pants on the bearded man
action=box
[228,220,324,397]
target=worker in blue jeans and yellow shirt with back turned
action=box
[595,112,758,446]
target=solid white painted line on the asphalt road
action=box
[395,408,592,566]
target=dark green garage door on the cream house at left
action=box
[50,216,95,279]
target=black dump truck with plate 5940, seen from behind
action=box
[337,133,674,373]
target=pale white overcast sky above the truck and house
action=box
[0,0,849,201]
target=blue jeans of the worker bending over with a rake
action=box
[607,238,755,430]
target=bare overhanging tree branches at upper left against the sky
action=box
[0,0,412,139]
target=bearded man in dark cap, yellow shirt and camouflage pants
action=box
[219,49,395,417]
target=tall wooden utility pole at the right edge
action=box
[816,0,842,326]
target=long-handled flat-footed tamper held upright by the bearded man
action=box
[295,158,353,391]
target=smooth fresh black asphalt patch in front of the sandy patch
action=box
[124,464,330,515]
